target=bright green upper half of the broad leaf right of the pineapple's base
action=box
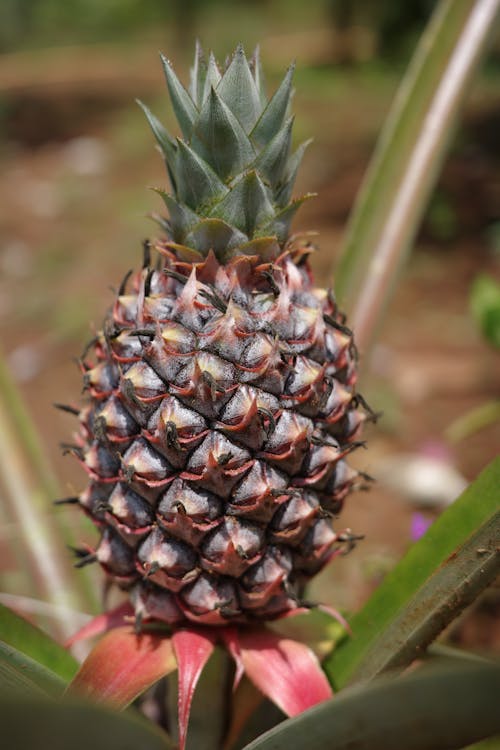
[325,458,500,687]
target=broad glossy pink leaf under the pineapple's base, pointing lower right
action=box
[238,628,332,716]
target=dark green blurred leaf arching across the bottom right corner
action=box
[245,664,500,750]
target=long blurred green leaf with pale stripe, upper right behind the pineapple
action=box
[336,0,499,350]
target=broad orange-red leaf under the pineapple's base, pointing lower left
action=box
[70,627,176,708]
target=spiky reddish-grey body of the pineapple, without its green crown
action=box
[80,244,363,624]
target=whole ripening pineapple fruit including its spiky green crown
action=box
[66,46,369,626]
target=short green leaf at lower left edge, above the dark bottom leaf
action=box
[0,604,78,681]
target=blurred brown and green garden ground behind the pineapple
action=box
[0,0,500,650]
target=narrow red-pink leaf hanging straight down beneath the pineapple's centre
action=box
[172,628,215,750]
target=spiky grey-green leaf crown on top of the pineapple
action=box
[139,44,311,261]
